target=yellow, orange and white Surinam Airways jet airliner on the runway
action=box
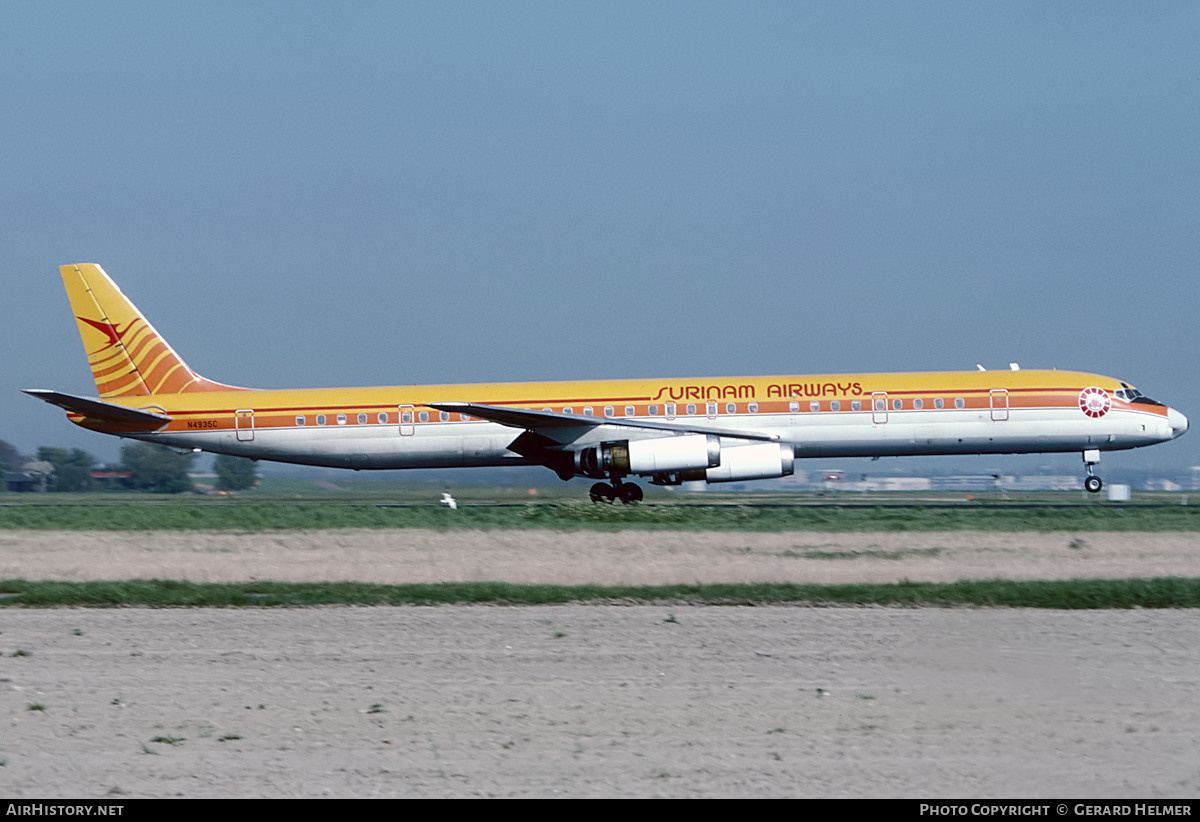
[25,263,1188,503]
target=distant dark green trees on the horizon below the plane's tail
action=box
[0,440,259,493]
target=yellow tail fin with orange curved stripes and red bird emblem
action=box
[59,263,236,397]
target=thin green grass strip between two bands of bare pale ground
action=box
[0,577,1200,610]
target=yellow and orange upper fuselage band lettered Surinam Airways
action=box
[87,370,1166,431]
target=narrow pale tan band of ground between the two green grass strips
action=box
[0,529,1200,586]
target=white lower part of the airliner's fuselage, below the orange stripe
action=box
[131,397,1187,469]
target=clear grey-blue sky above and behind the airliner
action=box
[0,1,1200,470]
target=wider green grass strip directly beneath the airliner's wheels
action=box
[0,496,1200,532]
